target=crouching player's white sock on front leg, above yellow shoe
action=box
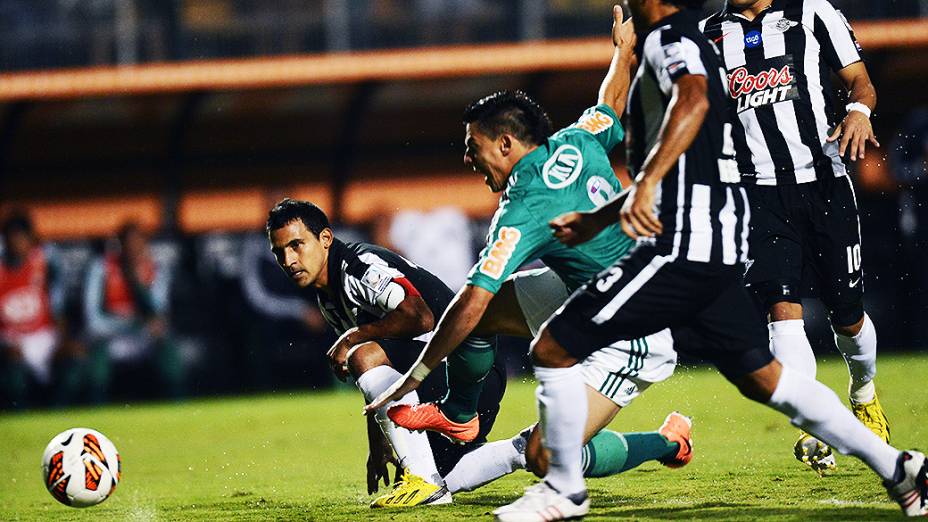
[357,366,442,485]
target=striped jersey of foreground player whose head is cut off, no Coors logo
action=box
[628,10,750,265]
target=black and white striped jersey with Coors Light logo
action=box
[700,0,860,185]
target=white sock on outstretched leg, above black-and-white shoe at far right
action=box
[767,366,899,480]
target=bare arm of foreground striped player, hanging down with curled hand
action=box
[620,74,709,239]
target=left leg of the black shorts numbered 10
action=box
[744,186,803,313]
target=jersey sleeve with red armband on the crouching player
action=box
[345,254,420,316]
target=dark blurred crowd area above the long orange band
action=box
[0,0,928,70]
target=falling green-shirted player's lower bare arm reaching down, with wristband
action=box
[364,285,494,414]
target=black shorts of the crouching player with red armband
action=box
[378,339,506,477]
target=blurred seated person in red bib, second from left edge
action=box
[84,223,184,403]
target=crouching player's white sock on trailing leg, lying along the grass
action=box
[445,426,532,494]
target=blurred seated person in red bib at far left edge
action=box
[0,211,83,408]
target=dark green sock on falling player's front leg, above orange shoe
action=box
[439,337,496,422]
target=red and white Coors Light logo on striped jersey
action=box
[728,57,799,112]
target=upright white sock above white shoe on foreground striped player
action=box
[535,365,587,496]
